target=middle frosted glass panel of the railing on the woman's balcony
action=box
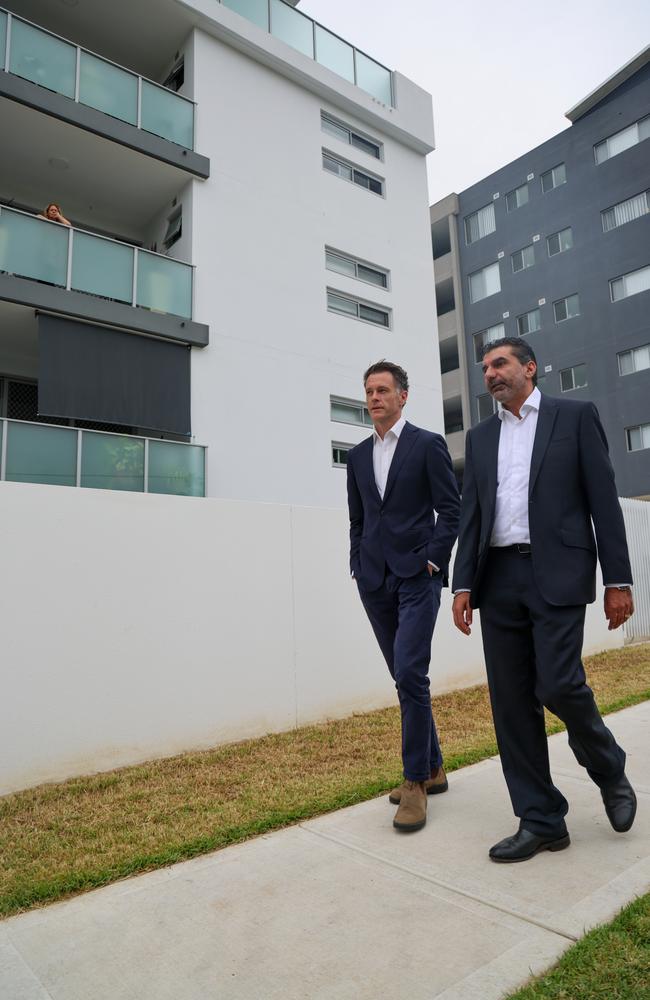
[72,232,133,304]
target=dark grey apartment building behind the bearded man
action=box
[431,47,650,497]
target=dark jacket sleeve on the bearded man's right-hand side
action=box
[579,403,632,585]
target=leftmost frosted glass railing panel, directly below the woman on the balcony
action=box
[0,209,70,287]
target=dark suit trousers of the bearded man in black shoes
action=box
[480,548,625,835]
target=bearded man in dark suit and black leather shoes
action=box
[453,337,636,862]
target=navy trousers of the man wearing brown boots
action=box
[359,569,442,781]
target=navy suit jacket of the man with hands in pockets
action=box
[347,422,460,591]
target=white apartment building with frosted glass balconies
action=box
[0,0,443,507]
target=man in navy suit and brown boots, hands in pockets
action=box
[347,361,459,832]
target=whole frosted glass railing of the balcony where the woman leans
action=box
[0,207,193,319]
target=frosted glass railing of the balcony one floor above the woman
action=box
[0,8,194,149]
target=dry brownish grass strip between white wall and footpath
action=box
[0,645,650,915]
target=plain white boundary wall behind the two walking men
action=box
[0,483,623,794]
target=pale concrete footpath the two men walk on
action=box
[0,702,650,1000]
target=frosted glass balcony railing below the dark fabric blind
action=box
[0,420,205,497]
